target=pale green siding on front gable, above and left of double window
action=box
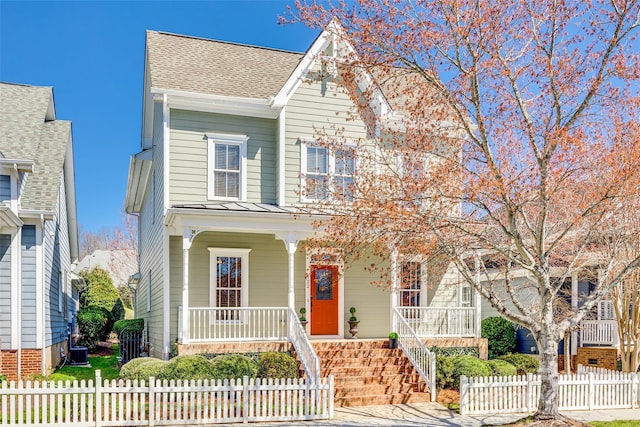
[285,72,367,205]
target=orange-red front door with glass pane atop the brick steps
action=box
[311,265,339,335]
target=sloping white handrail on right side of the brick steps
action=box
[393,307,436,402]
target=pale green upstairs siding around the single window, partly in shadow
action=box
[169,110,277,205]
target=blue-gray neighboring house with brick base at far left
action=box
[0,83,82,379]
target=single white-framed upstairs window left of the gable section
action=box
[207,133,249,200]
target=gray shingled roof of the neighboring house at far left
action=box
[0,83,71,211]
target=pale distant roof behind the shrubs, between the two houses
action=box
[74,249,138,286]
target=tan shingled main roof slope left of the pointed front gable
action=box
[147,30,304,99]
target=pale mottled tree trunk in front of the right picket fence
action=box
[535,330,560,420]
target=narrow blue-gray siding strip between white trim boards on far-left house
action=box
[20,224,37,348]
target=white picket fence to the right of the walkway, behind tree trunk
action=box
[460,371,640,415]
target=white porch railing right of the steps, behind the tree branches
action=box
[397,307,477,338]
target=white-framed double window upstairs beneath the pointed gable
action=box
[301,140,356,201]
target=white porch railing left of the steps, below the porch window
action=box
[178,307,289,342]
